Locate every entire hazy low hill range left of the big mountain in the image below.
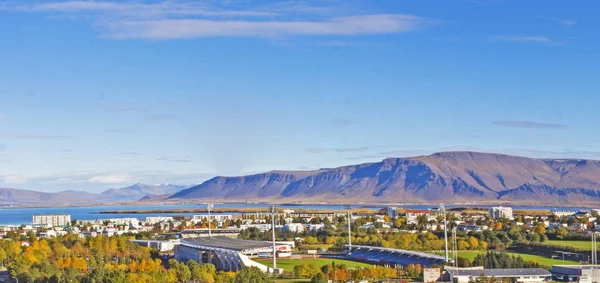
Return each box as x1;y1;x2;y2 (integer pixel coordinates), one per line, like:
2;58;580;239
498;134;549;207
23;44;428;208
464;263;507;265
0;183;186;205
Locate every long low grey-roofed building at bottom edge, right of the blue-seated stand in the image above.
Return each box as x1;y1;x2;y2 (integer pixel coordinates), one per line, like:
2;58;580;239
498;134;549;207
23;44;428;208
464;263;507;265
444;266;552;283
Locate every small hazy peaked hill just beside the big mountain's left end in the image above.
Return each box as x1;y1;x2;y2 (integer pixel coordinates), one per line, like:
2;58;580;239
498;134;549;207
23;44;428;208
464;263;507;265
101;183;187;202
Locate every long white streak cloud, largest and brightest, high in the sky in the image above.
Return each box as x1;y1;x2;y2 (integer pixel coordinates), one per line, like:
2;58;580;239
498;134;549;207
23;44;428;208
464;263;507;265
108;14;426;39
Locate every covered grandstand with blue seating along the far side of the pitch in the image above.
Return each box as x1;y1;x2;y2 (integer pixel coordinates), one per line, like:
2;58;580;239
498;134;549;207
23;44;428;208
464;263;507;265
345;245;445;266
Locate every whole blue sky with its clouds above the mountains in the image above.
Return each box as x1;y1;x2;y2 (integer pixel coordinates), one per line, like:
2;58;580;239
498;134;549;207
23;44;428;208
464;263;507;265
0;0;600;191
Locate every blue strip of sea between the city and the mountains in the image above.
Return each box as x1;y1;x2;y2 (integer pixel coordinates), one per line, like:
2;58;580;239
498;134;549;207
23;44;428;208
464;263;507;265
0;203;589;225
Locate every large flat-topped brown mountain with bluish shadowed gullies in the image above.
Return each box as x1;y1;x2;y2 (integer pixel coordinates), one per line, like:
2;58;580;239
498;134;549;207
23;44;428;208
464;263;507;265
169;152;600;205
